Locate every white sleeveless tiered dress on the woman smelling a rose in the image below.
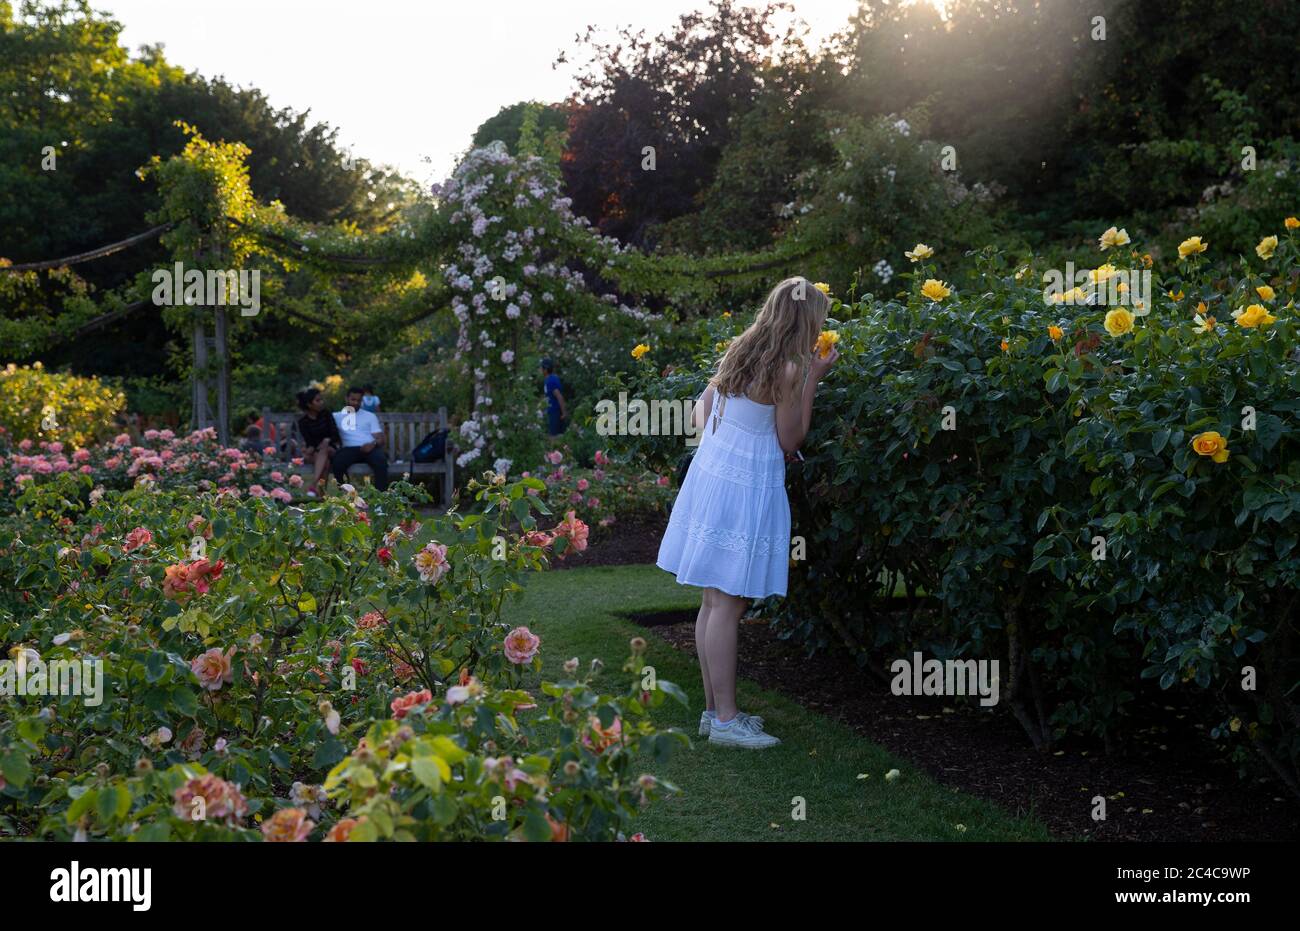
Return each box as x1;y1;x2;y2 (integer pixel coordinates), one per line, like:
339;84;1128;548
658;391;790;598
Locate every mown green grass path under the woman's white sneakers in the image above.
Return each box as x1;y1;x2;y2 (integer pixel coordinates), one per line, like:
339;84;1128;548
507;566;1050;841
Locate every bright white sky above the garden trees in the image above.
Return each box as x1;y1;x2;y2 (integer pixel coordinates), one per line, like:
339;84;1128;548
94;0;878;182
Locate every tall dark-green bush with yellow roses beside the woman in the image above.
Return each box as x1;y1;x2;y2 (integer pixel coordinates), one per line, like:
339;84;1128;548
613;221;1300;789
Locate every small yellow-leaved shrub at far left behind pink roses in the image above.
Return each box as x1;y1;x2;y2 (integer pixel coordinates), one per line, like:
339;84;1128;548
0;361;125;446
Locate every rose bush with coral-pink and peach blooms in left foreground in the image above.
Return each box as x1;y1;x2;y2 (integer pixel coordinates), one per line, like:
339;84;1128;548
0;472;677;840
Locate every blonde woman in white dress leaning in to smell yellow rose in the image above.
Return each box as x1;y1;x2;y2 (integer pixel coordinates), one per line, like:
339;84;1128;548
658;278;839;749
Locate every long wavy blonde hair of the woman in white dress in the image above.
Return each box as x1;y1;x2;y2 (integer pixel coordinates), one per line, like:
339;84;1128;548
709;277;831;404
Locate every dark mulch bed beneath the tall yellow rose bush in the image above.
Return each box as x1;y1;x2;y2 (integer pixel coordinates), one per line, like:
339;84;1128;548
632;611;1300;841
